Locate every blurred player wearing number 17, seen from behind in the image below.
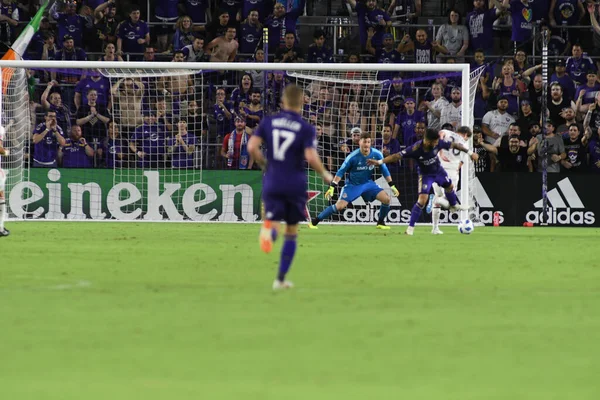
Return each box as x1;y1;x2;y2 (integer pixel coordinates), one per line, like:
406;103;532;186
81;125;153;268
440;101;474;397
248;85;333;290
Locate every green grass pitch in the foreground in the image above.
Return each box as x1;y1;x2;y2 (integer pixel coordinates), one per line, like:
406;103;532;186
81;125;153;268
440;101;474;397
0;222;600;400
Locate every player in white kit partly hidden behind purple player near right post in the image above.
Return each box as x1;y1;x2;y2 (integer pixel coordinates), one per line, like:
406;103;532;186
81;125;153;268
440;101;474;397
428;126;472;235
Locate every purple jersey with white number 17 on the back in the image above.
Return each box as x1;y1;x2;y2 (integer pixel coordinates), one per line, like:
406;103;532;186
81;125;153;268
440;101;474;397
255;111;317;198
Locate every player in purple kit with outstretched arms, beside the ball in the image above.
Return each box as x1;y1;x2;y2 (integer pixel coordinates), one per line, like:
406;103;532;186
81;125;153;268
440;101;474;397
367;128;479;235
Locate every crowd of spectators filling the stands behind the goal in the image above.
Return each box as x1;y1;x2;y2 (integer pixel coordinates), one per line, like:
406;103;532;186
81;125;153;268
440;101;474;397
0;0;600;173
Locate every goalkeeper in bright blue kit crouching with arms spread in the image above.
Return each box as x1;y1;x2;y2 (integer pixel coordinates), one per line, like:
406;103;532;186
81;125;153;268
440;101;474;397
308;132;400;229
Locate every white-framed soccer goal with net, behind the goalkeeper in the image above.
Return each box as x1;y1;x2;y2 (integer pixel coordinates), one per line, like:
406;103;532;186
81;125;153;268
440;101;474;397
0;61;481;223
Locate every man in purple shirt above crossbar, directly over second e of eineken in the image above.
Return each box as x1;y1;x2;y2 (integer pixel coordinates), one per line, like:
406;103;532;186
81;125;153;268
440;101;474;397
117;5;150;61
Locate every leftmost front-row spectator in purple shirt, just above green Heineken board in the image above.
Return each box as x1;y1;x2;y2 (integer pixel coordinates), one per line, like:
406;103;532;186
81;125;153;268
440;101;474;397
31;110;65;168
